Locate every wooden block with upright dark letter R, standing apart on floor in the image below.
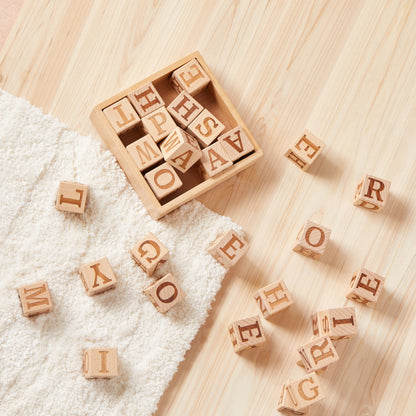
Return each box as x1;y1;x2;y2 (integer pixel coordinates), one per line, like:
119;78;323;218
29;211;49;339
354;175;391;211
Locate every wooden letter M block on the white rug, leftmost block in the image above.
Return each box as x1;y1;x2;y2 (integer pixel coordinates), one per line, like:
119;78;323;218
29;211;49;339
17;280;53;316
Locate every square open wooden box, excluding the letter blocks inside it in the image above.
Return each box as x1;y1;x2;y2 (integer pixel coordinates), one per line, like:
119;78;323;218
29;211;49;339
90;52;263;219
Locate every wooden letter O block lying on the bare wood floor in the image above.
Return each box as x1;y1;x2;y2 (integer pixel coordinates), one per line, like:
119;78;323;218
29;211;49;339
293;220;331;260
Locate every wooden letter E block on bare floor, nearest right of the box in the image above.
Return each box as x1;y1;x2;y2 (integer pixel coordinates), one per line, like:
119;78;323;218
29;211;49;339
285;130;325;170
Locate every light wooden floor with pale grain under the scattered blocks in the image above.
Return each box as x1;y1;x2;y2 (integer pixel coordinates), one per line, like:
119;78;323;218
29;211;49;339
0;0;416;416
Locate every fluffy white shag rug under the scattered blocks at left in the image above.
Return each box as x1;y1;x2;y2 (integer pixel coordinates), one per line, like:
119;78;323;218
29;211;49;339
0;90;241;416
